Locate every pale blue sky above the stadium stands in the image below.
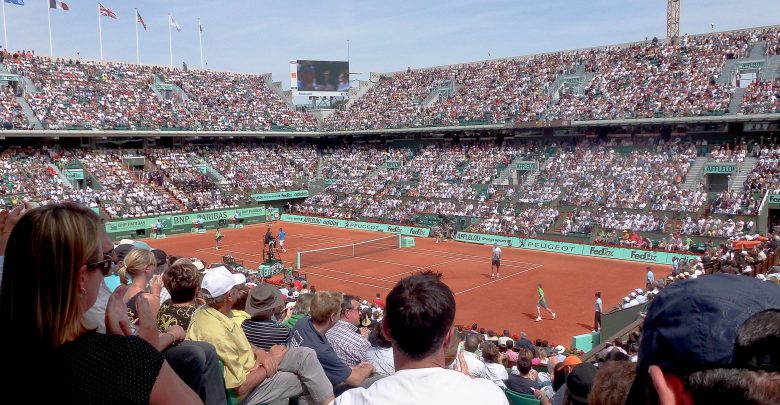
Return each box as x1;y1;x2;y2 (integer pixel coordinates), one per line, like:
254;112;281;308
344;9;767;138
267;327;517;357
5;0;780;88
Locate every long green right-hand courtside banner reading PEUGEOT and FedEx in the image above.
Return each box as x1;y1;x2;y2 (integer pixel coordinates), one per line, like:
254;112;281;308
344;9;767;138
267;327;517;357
455;232;699;264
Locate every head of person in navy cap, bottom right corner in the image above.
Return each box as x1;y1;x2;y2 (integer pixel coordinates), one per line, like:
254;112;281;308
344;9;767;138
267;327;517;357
626;274;780;405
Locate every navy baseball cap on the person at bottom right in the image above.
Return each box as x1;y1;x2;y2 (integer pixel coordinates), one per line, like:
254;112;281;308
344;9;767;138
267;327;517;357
637;274;780;375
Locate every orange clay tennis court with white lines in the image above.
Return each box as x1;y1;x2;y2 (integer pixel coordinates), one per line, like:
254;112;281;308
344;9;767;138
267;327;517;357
146;221;652;347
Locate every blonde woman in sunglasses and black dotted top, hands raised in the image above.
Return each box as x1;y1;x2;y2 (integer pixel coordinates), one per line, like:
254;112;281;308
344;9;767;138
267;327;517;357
0;203;200;404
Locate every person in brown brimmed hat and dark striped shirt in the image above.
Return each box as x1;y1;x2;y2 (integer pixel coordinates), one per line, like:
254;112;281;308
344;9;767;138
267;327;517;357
241;282;290;350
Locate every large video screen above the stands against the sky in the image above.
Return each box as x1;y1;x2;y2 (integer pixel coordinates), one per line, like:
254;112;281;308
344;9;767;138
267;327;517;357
290;60;349;95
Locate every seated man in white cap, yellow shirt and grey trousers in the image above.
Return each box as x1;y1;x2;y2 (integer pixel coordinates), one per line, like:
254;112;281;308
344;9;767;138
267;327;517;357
187;266;333;404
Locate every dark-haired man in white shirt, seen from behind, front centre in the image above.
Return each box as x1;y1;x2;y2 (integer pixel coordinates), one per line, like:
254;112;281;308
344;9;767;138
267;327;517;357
335;272;509;405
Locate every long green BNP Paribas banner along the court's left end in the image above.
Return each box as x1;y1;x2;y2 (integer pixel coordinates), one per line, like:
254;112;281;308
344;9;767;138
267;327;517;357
106;207;266;233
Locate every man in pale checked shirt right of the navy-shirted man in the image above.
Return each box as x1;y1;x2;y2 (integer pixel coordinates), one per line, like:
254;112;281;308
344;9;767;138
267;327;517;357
325;294;371;366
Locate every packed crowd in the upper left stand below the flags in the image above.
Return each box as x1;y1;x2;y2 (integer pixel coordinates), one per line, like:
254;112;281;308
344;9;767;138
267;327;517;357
3;52;317;131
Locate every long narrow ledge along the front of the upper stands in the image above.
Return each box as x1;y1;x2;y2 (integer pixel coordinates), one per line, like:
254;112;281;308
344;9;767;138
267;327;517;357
0;113;780;139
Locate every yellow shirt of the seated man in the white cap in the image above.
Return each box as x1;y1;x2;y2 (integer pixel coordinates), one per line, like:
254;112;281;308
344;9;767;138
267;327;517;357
187;305;255;388
